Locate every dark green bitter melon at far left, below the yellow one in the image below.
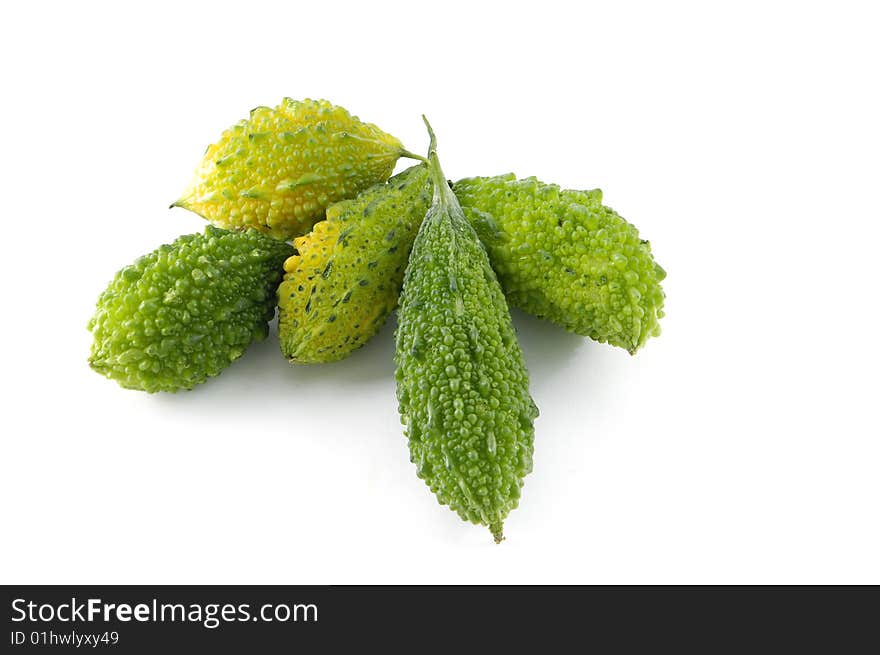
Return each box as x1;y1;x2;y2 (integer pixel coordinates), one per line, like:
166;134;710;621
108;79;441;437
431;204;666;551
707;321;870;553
89;227;293;393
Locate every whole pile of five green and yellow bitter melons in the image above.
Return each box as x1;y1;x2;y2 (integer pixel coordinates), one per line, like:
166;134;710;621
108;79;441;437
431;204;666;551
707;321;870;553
89;99;665;541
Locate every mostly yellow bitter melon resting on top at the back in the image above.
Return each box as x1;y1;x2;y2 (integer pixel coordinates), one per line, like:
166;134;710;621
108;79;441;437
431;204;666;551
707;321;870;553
172;98;403;239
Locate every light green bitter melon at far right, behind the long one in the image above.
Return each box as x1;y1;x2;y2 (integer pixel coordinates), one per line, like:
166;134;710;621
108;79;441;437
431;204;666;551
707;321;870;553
454;174;666;353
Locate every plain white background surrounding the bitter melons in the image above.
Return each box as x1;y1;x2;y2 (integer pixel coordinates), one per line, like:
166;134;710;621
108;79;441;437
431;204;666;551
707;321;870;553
0;0;880;583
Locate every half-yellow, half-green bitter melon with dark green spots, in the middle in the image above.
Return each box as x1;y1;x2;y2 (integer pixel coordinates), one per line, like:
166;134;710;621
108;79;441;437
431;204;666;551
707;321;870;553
278;164;431;363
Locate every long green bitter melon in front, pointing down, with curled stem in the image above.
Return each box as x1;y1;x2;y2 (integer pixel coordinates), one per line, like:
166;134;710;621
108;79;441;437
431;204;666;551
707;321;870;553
396;154;538;542
